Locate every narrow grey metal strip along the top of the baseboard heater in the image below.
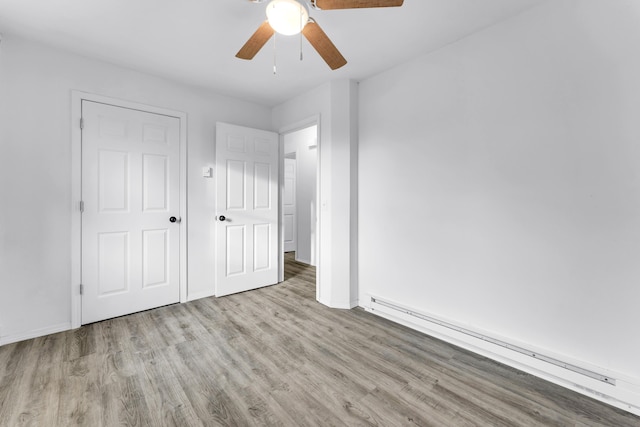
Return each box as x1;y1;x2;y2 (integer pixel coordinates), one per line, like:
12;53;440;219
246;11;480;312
371;297;616;386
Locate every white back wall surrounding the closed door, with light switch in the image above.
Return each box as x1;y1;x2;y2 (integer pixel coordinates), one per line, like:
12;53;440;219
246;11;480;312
0;35;271;343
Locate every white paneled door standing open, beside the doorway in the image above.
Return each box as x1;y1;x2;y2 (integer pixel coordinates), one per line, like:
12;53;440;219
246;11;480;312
215;123;279;296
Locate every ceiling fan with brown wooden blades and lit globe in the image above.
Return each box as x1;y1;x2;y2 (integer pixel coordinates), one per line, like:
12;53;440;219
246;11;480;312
236;0;404;70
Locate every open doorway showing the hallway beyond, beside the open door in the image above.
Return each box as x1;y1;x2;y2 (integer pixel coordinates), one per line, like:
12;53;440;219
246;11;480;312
281;124;318;266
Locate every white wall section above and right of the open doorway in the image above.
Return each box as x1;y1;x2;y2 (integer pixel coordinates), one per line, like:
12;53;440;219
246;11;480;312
273;80;358;308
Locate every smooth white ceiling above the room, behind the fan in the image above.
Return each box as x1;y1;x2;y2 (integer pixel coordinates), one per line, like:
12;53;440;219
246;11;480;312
0;0;544;106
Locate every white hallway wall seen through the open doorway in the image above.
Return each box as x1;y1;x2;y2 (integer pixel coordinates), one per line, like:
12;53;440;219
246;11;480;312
283;125;318;265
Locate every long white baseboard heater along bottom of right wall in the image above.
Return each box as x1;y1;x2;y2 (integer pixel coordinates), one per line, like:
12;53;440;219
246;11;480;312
363;296;640;415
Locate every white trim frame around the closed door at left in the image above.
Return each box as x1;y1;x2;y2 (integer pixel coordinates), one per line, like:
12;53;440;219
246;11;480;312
71;90;188;329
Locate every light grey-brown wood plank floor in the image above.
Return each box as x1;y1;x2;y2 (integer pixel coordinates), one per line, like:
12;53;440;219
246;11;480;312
0;252;640;427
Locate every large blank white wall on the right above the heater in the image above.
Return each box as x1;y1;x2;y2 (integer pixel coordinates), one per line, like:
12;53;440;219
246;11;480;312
359;0;640;411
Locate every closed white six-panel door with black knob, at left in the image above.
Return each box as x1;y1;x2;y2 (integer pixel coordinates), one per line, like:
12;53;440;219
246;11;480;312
82;100;180;324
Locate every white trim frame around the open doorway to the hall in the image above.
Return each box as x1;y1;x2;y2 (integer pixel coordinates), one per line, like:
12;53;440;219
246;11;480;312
278;114;322;300
